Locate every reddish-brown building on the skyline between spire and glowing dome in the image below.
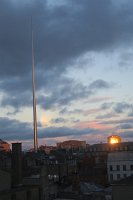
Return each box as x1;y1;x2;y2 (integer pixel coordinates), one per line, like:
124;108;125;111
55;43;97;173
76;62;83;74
57;140;86;149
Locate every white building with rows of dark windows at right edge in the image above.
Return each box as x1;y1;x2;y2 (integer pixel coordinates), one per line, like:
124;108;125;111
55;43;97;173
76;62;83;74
107;151;133;182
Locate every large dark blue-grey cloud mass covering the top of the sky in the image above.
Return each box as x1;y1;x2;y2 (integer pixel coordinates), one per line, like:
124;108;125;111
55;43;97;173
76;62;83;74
0;0;133;111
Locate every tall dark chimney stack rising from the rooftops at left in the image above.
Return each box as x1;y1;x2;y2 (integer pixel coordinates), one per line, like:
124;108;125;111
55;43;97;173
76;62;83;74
12;143;22;187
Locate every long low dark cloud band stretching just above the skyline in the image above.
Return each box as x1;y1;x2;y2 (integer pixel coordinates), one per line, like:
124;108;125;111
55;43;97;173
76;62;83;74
0;117;133;144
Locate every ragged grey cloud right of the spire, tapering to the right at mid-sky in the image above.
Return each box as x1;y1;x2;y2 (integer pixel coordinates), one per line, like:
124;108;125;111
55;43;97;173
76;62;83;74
39;79;111;109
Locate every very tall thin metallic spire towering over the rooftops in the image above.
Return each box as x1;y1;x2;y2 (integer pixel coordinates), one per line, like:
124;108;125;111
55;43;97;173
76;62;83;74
31;17;38;152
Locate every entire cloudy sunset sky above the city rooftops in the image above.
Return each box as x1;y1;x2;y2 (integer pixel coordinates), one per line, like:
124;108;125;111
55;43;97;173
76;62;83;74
0;0;133;148
